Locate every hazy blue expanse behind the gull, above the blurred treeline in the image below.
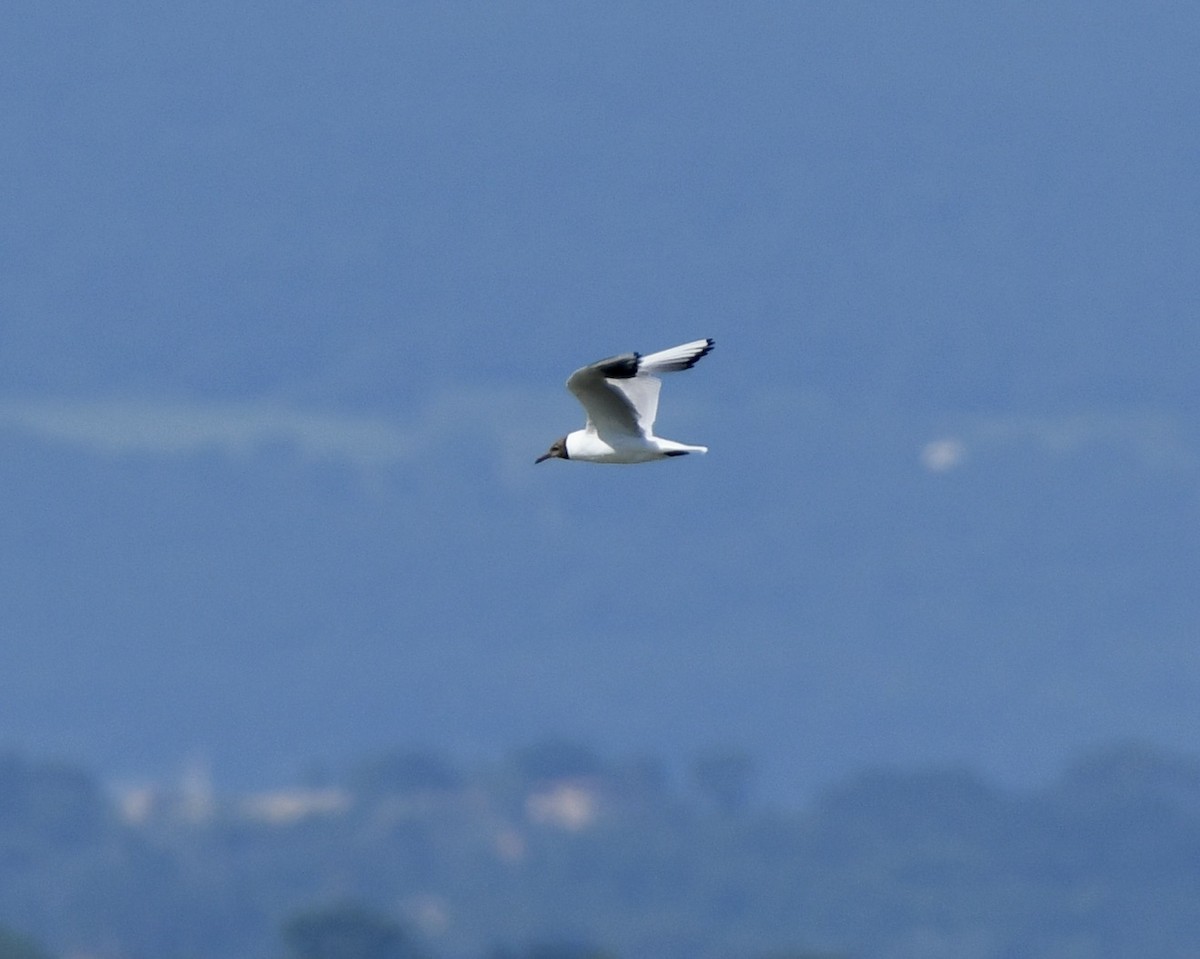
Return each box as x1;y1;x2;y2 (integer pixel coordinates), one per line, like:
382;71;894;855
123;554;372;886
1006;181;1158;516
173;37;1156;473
0;2;1200;792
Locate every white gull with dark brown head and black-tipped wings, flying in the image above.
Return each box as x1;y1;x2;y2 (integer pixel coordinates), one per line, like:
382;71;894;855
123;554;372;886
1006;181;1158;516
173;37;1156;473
535;340;713;463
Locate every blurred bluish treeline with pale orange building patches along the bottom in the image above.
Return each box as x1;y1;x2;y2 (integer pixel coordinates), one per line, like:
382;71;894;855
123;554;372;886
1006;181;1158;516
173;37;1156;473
0;742;1200;959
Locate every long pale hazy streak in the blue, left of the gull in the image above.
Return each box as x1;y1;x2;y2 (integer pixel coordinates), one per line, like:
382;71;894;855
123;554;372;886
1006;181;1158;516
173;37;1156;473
0;400;419;467
